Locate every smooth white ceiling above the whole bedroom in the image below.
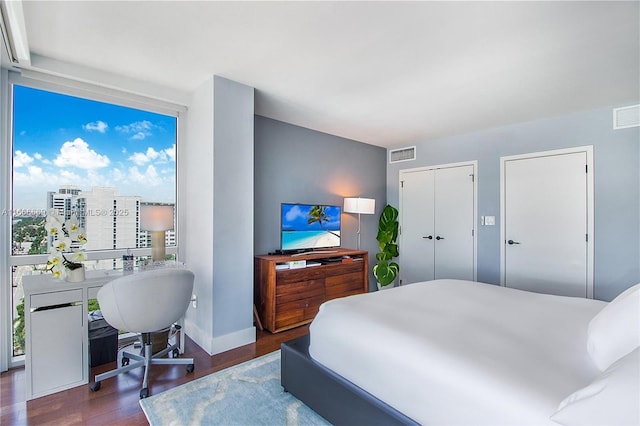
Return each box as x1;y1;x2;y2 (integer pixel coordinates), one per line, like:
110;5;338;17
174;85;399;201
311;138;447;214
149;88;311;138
12;1;640;147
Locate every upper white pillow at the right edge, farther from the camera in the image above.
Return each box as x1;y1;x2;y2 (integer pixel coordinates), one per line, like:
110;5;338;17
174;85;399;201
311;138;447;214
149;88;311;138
587;284;640;371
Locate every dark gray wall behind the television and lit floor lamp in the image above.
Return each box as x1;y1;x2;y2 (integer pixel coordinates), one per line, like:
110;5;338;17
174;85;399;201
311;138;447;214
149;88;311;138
254;116;387;288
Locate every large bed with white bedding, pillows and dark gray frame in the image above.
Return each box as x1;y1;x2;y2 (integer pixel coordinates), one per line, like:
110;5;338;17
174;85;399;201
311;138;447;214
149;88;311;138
282;280;640;425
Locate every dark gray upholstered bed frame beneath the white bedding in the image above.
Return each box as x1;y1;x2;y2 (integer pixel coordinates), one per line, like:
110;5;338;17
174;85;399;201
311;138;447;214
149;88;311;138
280;335;418;425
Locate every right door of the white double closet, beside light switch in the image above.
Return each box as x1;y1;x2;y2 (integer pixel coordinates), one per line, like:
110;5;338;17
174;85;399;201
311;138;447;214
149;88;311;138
433;165;475;281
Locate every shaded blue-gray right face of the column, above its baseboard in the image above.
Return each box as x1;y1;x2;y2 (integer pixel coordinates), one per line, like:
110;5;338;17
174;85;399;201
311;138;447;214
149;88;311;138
214;76;254;336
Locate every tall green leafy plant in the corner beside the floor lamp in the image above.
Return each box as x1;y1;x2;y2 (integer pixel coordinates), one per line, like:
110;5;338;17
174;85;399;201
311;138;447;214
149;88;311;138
373;204;400;289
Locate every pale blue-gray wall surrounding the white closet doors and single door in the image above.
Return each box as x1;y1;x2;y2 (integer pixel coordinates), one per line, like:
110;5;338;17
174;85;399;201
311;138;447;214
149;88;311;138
387;107;640;300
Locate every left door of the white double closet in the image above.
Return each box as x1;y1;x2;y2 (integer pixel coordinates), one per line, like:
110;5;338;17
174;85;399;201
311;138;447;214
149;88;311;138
399;170;435;284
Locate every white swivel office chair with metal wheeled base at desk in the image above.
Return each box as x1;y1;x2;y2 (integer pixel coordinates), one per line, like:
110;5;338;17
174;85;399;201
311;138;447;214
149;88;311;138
91;268;194;398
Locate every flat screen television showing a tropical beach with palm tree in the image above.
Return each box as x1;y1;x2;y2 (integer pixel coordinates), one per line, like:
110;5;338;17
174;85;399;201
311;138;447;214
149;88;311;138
280;203;341;252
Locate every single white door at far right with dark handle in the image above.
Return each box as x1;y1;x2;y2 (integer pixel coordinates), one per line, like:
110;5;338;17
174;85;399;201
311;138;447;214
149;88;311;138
502;150;592;297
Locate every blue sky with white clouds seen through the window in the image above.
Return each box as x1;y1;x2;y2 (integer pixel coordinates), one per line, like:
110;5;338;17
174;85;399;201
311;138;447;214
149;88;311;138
13;86;176;209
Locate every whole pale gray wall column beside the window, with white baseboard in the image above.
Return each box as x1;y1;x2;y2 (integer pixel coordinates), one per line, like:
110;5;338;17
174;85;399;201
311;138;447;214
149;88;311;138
178;76;256;354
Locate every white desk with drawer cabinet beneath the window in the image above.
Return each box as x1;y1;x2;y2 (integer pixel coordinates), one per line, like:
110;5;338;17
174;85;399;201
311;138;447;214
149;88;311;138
22;271;184;400
